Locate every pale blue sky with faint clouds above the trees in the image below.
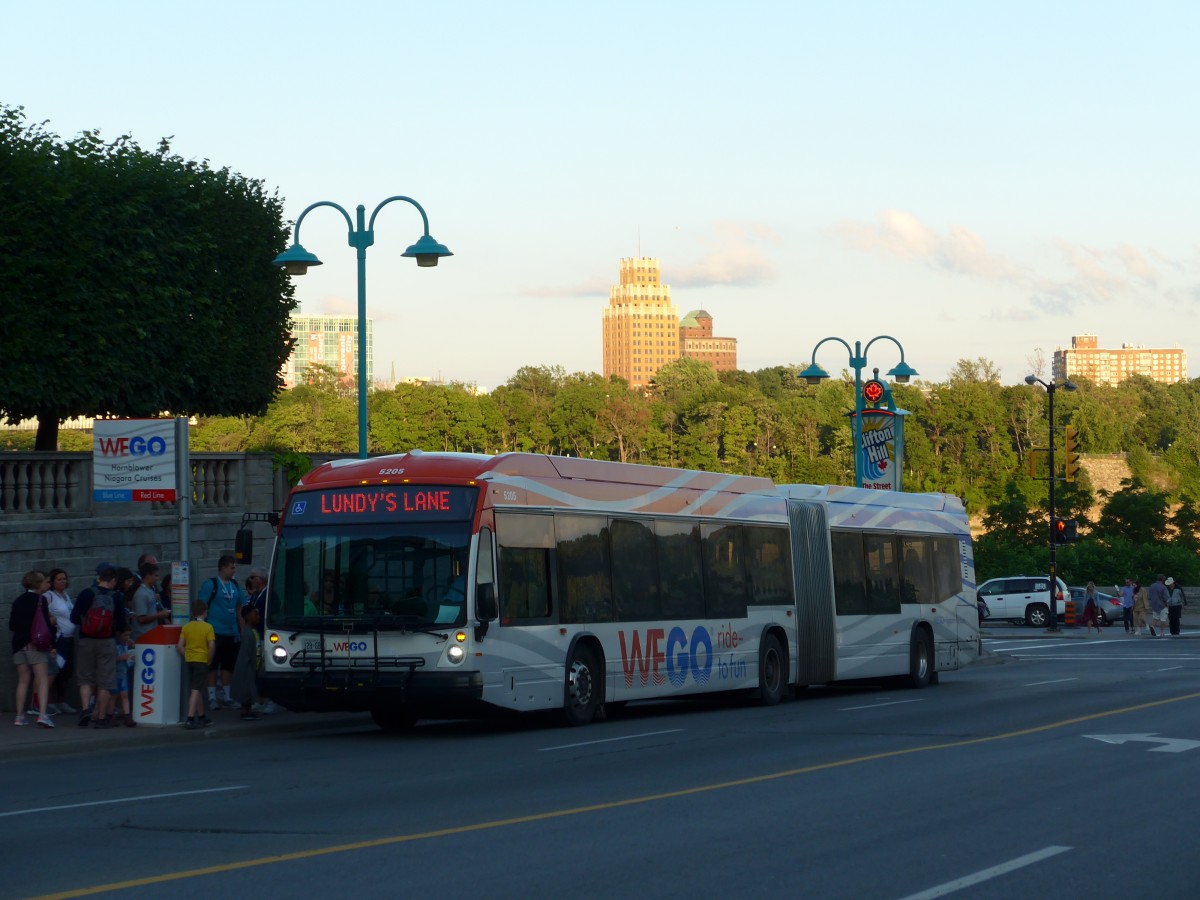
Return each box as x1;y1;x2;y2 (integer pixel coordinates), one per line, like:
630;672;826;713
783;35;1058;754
0;0;1200;389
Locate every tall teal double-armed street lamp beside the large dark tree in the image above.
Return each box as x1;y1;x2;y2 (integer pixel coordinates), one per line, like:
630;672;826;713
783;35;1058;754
275;197;454;460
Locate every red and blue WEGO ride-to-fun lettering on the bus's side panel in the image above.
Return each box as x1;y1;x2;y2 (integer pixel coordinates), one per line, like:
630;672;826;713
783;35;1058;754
618;625;745;688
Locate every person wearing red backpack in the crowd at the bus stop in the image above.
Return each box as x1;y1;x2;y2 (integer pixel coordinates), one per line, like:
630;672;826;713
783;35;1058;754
71;563;126;728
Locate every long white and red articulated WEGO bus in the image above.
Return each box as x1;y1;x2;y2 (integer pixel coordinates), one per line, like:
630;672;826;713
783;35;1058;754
260;450;979;730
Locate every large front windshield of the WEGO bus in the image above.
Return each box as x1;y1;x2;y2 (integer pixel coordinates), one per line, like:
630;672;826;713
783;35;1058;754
266;522;470;630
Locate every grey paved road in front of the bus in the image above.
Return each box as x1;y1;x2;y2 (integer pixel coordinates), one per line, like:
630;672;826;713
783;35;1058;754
0;630;1200;898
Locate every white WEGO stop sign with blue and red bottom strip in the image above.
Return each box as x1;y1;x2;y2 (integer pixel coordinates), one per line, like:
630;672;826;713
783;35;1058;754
91;419;175;503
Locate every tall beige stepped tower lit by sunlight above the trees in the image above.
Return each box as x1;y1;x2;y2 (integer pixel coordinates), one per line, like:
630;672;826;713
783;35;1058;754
604;257;679;388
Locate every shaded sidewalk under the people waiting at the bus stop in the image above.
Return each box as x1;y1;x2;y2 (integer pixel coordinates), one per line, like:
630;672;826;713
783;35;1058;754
0;707;371;762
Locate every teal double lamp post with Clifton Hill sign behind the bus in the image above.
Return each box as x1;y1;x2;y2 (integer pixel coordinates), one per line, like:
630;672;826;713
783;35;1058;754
798;335;919;491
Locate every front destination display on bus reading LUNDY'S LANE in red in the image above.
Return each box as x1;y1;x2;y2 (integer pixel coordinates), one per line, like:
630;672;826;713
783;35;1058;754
286;485;479;526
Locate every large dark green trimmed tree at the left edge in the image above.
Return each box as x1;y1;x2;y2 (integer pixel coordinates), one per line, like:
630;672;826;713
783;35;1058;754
0;106;294;450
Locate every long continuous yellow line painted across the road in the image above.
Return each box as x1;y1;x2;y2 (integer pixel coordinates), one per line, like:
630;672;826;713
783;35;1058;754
38;692;1200;900
